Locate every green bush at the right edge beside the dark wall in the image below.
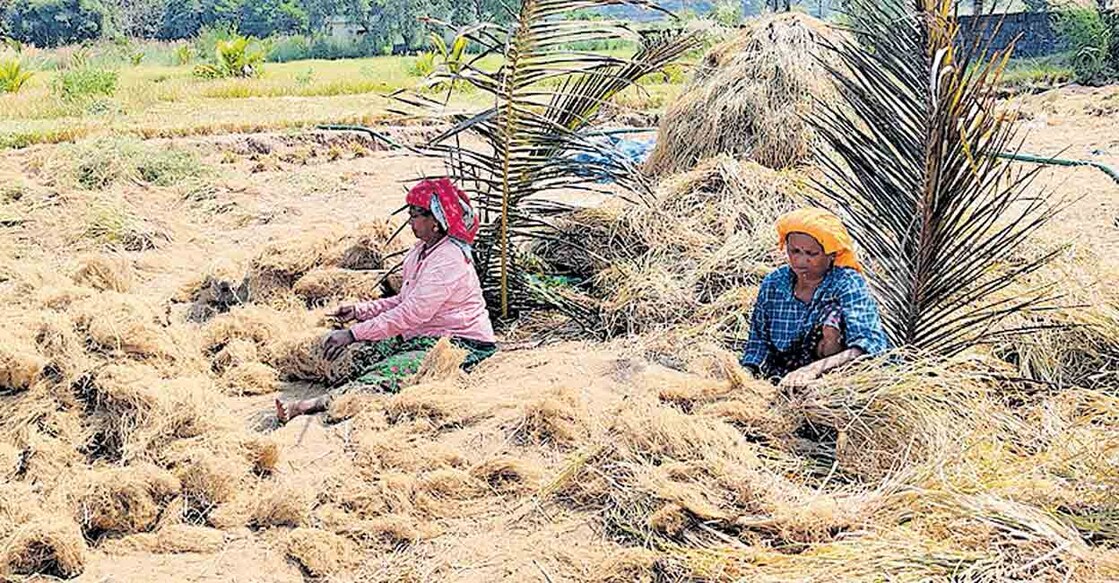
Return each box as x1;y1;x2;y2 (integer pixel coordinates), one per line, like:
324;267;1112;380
1054;7;1119;85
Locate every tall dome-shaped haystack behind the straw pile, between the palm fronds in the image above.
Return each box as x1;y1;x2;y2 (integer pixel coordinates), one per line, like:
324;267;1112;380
645;12;830;176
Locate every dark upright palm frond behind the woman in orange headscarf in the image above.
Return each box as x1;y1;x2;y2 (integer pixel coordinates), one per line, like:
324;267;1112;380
814;0;1061;352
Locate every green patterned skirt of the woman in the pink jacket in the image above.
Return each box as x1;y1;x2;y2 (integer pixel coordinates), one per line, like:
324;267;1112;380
326;337;497;393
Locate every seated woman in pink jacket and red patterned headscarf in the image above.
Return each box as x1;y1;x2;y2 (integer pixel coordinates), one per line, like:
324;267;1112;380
275;178;497;423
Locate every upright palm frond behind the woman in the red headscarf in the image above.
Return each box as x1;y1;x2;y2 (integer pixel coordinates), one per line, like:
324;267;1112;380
397;0;699;318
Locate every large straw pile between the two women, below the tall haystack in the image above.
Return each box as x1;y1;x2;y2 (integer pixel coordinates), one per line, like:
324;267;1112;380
536;156;805;344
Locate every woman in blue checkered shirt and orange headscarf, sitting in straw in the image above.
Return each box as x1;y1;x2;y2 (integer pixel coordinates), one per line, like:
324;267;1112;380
742;208;890;386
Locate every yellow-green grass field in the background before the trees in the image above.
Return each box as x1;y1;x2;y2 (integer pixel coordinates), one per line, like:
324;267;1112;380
0;46;683;148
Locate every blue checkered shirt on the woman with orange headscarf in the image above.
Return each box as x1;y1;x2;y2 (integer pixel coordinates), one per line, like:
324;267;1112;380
742;265;890;370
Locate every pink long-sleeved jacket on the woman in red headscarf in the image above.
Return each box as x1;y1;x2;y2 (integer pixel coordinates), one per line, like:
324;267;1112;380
350;237;495;342
